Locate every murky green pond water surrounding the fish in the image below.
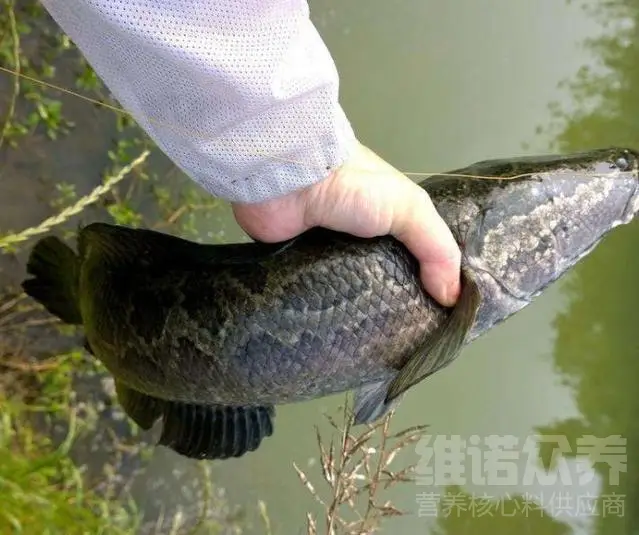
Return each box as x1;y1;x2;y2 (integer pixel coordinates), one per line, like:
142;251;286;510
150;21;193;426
0;0;639;535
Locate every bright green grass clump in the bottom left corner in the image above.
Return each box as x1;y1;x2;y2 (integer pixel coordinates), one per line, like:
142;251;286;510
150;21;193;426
0;399;139;534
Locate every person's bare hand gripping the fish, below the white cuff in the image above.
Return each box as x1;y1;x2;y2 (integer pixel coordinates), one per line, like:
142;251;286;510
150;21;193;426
233;144;461;306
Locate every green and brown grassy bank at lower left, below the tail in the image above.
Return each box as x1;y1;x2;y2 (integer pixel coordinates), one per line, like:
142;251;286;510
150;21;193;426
0;294;140;534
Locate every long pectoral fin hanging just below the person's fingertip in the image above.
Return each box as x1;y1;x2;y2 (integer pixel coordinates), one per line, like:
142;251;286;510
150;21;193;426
385;273;481;403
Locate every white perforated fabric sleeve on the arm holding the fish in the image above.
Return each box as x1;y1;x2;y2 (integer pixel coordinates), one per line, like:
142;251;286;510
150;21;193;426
42;0;355;202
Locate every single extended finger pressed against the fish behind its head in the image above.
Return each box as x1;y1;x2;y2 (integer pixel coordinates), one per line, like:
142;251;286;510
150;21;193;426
391;179;461;306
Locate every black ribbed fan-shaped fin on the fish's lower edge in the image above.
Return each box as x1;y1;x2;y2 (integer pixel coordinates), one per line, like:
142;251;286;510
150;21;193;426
159;402;275;460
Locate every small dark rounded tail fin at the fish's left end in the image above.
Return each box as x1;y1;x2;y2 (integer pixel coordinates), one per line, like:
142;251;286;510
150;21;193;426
22;236;82;325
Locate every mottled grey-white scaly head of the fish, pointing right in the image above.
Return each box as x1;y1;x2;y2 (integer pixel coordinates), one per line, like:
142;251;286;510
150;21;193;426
440;149;639;340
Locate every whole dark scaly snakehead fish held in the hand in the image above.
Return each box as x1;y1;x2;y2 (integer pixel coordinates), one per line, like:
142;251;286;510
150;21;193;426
22;147;639;460
